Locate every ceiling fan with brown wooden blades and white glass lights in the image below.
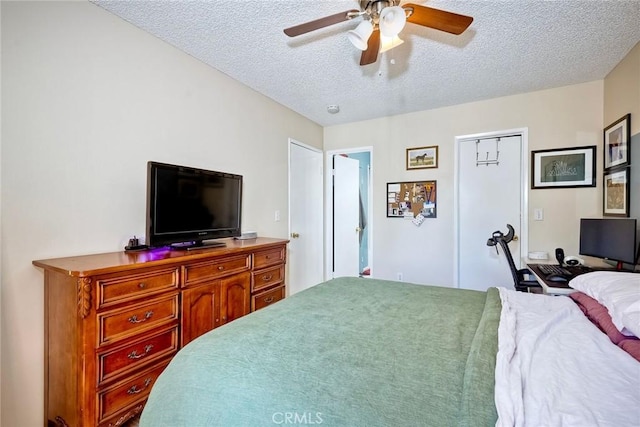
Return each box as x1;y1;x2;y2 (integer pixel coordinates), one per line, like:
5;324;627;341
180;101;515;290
284;0;473;65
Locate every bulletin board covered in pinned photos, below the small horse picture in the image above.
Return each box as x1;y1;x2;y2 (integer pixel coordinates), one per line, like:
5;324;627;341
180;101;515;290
387;181;437;219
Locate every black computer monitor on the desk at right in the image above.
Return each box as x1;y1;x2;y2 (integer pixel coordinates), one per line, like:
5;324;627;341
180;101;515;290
580;218;638;270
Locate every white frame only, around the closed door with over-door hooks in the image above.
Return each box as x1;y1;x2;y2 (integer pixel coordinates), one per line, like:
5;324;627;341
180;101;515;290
453;127;529;288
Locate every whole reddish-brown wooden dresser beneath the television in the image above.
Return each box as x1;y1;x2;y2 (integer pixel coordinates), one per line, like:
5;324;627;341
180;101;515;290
33;237;287;427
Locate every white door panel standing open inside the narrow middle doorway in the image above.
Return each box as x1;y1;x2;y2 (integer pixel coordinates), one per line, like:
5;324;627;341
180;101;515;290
332;155;360;277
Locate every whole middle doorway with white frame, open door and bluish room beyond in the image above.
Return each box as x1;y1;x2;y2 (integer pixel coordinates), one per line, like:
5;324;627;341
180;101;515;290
325;147;373;279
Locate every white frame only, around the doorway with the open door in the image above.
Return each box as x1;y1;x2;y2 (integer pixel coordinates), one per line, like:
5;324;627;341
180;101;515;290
324;146;375;280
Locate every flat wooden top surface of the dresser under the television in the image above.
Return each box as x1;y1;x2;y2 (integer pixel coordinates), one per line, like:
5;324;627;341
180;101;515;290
33;237;288;277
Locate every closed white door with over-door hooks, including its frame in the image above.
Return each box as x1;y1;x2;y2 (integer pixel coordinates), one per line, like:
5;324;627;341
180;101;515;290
454;128;528;291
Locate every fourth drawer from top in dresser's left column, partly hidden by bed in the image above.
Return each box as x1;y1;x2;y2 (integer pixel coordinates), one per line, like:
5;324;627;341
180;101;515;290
97;361;169;425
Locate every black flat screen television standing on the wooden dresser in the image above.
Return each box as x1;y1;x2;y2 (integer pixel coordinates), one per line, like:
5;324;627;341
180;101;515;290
146;162;242;249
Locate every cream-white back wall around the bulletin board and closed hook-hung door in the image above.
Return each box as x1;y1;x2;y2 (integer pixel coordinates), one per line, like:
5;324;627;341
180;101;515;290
324;81;603;286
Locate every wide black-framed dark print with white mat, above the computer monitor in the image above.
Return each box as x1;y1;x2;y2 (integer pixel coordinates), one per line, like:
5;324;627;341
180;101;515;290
531;145;596;189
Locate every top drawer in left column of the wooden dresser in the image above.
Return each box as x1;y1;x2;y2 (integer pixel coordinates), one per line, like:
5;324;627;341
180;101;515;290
96;267;179;309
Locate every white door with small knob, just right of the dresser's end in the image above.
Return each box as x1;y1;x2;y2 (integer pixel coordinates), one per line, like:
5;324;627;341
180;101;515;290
287;138;324;295
